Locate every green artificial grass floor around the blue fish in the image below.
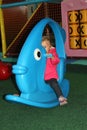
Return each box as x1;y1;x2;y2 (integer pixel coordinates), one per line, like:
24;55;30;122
0;64;87;130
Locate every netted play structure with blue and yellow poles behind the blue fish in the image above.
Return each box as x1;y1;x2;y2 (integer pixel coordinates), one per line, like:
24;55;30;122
0;0;61;62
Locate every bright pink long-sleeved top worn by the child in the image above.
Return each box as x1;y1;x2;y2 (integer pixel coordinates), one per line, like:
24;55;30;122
44;47;60;80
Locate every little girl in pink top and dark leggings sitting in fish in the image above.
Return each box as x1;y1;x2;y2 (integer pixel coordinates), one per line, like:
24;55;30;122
42;36;67;106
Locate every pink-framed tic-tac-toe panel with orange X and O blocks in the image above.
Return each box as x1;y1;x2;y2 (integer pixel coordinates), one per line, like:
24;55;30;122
61;0;87;58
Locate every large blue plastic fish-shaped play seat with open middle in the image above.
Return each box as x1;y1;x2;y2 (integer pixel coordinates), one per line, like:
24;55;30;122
5;18;69;108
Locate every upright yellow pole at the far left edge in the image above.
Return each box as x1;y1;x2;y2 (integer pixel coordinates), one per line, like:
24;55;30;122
0;0;6;58
